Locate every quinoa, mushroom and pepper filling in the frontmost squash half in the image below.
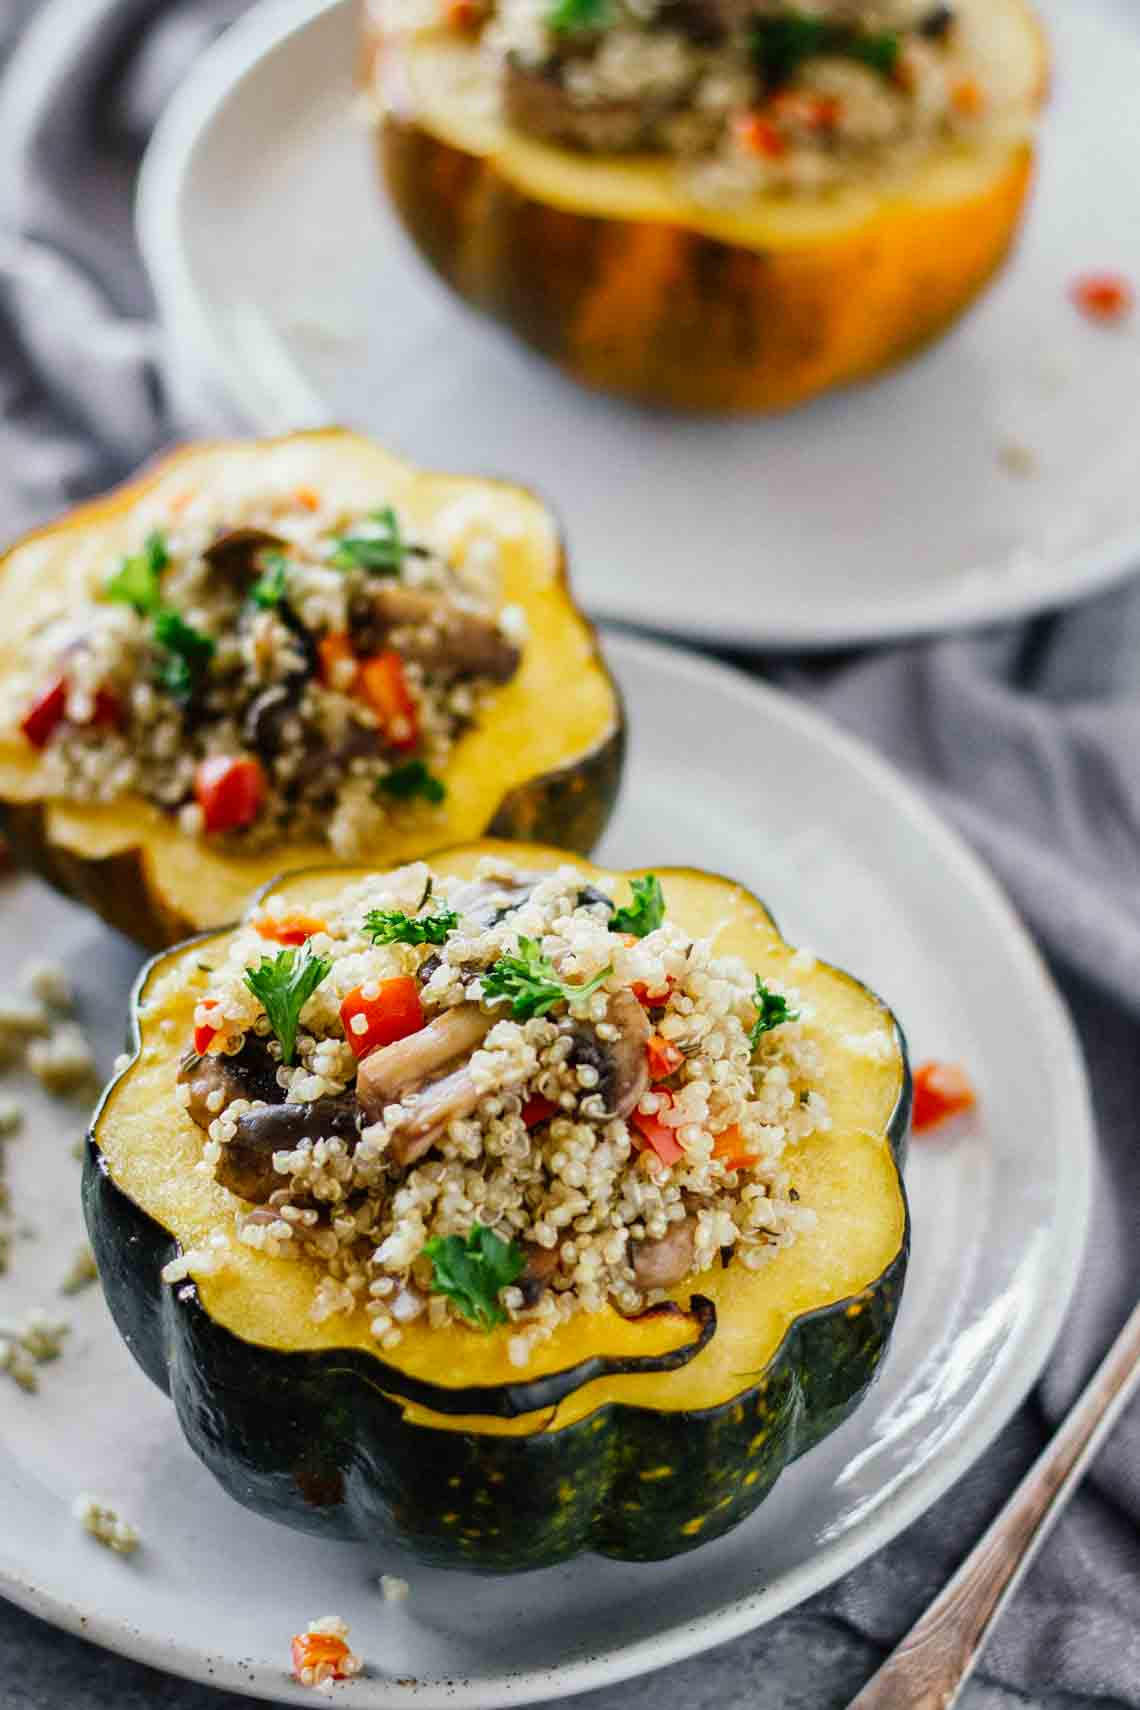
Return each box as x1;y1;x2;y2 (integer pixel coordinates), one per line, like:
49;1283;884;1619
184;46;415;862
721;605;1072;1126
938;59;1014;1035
171;857;831;1366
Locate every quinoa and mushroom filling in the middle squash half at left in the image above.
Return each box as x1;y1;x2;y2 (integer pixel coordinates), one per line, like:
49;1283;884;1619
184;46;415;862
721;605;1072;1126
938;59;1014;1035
3;487;525;858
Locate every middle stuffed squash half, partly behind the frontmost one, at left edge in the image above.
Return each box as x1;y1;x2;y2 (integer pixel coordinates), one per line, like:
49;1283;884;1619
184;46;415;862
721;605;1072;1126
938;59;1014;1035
0;431;624;949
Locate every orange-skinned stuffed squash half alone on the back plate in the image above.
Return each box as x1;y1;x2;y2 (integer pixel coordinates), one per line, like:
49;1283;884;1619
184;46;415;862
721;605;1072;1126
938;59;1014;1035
364;0;1046;410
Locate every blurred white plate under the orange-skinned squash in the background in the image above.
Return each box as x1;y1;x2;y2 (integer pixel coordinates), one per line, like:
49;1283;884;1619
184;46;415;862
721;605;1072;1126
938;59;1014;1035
140;0;1140;646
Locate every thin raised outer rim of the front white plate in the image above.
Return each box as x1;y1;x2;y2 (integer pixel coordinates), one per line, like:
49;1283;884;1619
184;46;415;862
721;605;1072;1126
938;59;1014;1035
0;634;1094;1710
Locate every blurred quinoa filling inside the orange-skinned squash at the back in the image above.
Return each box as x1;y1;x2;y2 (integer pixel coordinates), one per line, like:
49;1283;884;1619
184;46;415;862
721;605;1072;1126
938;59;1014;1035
440;0;1031;195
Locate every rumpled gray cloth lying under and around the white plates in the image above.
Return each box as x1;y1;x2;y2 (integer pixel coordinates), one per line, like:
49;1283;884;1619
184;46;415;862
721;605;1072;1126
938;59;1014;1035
0;0;1140;1710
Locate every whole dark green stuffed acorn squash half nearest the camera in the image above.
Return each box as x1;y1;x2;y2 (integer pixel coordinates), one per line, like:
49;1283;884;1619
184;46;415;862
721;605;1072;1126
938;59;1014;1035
84;843;909;1571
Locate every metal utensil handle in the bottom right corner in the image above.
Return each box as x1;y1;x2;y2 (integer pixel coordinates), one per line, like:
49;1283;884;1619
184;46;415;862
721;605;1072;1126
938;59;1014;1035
849;1305;1140;1710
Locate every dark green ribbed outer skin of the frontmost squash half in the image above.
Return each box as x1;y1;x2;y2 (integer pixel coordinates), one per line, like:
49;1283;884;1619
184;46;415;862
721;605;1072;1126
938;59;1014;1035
82;934;911;1573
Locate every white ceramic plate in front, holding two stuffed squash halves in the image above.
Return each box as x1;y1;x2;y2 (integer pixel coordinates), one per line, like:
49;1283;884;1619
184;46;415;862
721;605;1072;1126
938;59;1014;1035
0;640;1090;1710
